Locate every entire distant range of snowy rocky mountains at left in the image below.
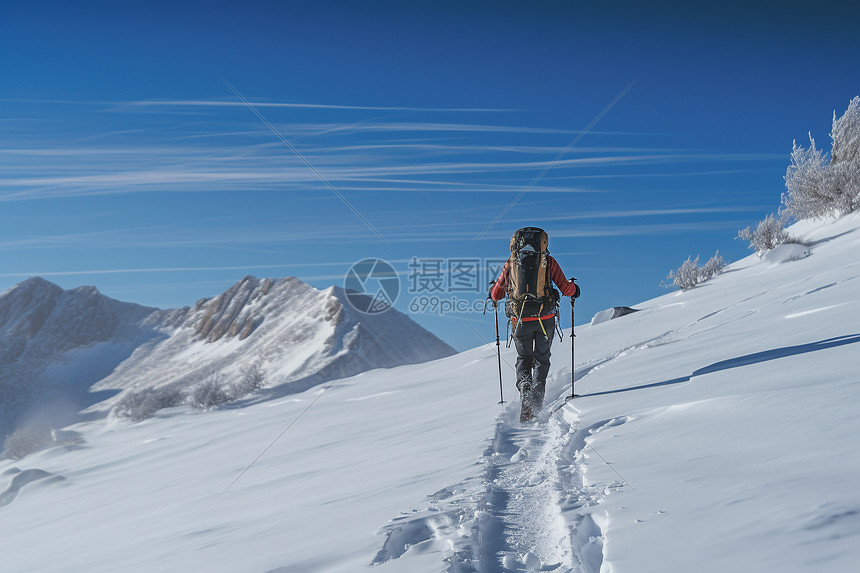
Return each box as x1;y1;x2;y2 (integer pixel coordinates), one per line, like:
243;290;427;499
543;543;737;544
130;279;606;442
0;276;455;437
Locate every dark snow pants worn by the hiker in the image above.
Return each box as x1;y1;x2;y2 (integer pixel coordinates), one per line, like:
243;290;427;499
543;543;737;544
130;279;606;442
514;316;555;410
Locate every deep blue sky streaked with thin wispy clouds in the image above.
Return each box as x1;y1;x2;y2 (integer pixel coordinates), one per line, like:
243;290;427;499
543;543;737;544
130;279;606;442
0;2;860;349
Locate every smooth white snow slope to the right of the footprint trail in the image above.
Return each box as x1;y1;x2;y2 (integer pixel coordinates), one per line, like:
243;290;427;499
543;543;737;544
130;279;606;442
565;214;860;572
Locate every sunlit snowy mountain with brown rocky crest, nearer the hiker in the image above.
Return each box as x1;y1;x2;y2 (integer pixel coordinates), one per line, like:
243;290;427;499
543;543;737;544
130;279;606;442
89;277;454;409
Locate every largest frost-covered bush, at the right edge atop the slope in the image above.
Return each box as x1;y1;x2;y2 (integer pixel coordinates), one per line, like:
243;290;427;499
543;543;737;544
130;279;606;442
782;97;860;219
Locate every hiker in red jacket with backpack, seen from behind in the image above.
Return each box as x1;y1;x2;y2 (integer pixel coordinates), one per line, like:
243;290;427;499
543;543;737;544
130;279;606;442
489;227;580;421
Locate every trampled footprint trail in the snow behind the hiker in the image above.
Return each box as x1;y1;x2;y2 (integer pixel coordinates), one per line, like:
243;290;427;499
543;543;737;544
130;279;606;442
371;378;624;573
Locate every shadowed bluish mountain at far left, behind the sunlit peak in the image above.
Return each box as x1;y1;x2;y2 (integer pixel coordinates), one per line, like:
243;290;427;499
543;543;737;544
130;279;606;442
0;278;156;435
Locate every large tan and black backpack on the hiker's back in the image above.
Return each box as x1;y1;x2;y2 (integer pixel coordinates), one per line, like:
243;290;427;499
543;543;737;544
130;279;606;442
505;227;560;319
